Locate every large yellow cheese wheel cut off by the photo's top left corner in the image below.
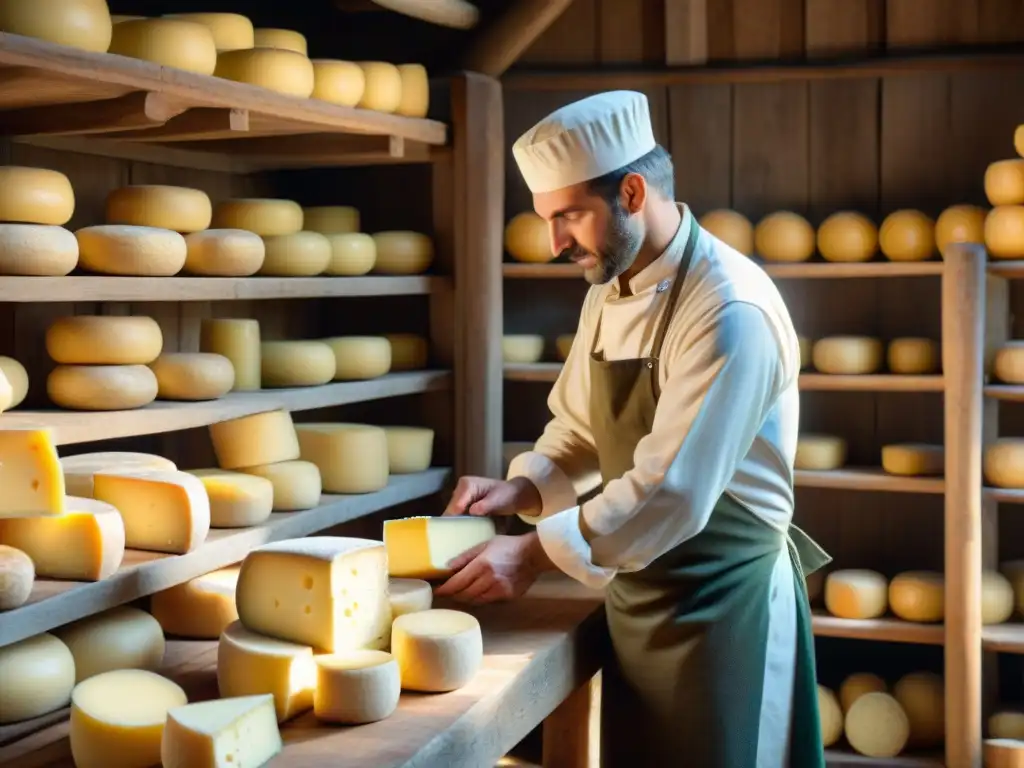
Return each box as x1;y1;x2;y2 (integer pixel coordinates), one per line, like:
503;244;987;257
0;0;113;51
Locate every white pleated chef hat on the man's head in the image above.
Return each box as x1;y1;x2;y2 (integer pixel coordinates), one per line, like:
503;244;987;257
512;91;657;194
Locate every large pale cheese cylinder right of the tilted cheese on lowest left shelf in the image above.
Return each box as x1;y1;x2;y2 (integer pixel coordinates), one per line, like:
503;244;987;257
295;423;388;494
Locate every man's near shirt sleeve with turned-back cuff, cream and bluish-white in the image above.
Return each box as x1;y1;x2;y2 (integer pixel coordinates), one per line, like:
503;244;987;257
538;301;784;588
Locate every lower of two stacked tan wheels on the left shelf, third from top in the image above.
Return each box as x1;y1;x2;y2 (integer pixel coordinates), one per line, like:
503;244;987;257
46;366;158;411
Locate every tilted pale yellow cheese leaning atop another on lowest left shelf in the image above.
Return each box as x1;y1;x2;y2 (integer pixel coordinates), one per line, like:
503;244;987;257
210;411;299;469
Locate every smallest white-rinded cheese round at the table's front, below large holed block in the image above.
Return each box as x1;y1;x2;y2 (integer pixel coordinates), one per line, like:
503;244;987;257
313;650;401;725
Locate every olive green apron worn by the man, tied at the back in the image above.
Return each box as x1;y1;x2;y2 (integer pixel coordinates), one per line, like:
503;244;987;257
590;218;830;768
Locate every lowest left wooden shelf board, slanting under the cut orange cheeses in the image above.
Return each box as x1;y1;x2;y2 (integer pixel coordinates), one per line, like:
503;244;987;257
0;469;449;647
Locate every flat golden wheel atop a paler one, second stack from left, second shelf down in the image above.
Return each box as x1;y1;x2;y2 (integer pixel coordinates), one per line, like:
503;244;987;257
106;184;213;232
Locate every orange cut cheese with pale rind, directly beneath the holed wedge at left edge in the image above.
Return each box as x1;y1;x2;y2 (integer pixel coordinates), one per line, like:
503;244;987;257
0;495;125;581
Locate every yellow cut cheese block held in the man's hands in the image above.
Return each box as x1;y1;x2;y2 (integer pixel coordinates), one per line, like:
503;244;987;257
384;515;495;579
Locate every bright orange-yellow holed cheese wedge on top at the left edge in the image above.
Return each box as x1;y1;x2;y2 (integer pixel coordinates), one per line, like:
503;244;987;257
0;429;66;518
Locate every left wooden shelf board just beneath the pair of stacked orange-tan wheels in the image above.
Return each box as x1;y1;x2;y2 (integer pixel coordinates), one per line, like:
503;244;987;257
0;371;452;445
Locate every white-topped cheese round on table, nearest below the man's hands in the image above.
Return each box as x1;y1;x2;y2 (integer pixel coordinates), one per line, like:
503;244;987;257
391;608;483;693
